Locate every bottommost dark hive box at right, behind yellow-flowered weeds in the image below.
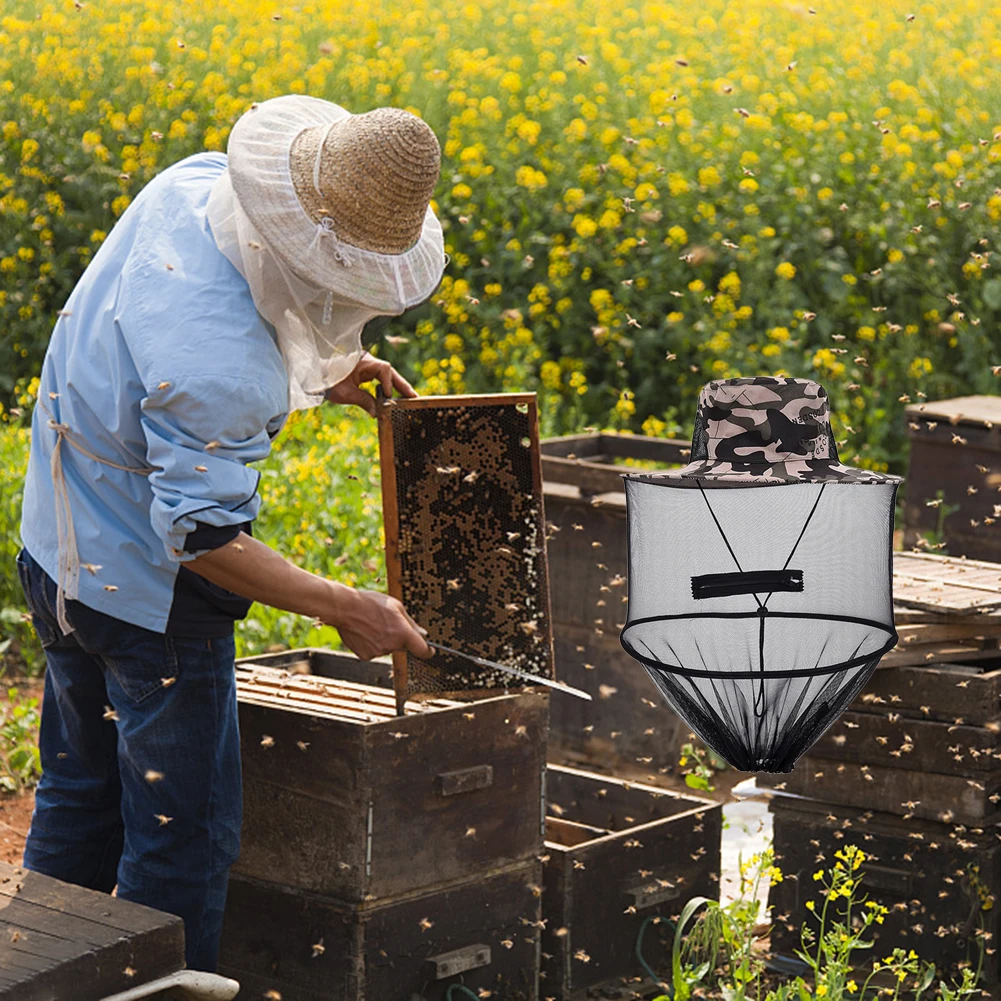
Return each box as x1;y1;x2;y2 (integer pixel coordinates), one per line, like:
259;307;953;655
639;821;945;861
769;796;1001;987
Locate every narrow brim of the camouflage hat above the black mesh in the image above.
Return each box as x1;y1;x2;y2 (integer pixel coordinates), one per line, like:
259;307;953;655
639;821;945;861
625;458;904;487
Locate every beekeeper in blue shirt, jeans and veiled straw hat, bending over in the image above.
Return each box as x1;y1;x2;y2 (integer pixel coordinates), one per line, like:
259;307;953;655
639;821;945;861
17;95;445;970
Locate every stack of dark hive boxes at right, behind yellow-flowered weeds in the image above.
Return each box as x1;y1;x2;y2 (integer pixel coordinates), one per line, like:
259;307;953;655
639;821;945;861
758;658;1001;986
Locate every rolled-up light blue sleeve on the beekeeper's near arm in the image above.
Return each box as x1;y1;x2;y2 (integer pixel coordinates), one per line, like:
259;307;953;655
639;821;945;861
141;373;280;563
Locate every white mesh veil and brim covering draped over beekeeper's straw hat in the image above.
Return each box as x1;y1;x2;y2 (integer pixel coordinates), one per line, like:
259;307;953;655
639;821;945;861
206;95;445;410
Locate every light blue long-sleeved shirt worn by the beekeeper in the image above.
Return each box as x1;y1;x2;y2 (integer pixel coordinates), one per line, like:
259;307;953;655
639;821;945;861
21;152;288;633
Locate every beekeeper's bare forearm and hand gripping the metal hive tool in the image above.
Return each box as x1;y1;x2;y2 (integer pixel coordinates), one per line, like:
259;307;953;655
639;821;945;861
185;533;432;660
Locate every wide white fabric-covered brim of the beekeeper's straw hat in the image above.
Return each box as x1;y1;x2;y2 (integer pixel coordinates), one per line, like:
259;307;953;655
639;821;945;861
226;94;445;313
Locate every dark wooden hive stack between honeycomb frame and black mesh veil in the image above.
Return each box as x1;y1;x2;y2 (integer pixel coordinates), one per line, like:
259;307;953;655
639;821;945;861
541;432;690;772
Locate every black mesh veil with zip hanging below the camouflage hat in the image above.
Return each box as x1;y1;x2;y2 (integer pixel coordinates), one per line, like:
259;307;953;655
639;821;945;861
620;475;898;772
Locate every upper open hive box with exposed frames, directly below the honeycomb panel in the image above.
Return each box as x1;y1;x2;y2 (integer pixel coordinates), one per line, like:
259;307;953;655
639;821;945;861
233;650;549;902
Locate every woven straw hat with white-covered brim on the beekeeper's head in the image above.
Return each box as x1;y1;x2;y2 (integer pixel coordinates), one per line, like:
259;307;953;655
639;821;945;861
226;94;444;313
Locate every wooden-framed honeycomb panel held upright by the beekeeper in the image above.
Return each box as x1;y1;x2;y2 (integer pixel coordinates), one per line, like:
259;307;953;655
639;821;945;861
376;390;555;706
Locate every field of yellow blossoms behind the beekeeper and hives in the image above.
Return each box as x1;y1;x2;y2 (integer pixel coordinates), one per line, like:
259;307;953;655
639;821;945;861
0;0;1001;652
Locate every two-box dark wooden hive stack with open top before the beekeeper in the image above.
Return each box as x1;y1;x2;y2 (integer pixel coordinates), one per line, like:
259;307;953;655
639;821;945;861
220;651;549;1001
